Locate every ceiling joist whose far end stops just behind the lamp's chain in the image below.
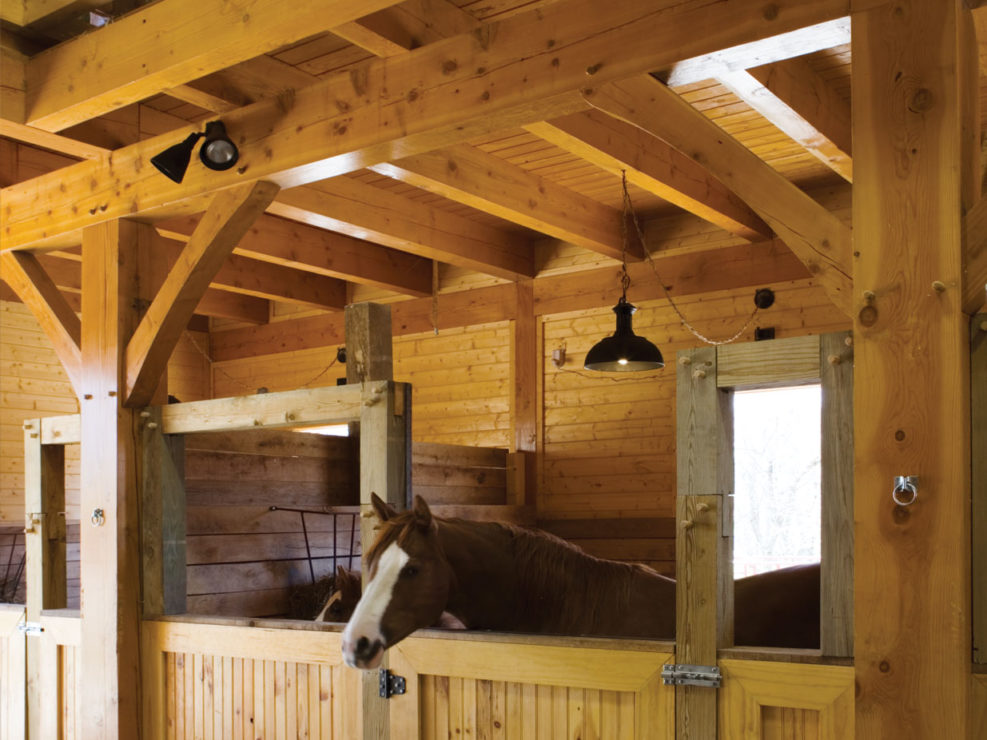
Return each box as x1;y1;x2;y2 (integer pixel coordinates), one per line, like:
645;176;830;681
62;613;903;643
371;144;628;259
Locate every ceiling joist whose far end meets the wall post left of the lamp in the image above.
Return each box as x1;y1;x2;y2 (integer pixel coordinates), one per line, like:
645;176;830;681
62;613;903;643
268;177;535;280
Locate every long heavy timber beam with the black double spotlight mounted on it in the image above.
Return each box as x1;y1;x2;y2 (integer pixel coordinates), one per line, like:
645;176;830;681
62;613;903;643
0;0;846;249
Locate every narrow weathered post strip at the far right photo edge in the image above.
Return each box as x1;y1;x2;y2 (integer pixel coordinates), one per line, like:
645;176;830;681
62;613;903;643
970;313;987;665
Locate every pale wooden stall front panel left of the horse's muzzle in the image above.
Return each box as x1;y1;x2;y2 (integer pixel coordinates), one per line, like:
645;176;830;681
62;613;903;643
141;619;363;740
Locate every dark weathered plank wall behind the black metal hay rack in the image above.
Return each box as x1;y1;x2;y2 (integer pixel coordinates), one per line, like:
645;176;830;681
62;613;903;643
185;431;360;616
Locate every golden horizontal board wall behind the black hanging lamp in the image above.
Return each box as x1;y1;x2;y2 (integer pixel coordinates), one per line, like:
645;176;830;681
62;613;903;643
538;280;848;532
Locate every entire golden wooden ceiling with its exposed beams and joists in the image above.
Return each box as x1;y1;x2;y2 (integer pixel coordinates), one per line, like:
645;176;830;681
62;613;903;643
0;0;983;346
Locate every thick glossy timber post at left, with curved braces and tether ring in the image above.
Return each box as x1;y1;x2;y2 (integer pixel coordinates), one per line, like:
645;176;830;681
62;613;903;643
78;221;149;740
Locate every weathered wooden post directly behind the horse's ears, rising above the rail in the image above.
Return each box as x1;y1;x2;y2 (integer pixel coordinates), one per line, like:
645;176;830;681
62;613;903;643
345;303;411;740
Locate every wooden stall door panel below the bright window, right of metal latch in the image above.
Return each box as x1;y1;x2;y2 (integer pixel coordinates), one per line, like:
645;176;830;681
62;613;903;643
718;660;854;740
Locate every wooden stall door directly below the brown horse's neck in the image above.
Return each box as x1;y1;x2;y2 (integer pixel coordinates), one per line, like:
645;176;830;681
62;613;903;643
390;634;675;740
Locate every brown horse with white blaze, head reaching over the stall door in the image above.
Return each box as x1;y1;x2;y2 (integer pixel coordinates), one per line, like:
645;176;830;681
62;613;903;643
343;496;819;668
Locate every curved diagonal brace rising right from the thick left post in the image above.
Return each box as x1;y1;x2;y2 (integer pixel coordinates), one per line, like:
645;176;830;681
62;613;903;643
124;182;278;406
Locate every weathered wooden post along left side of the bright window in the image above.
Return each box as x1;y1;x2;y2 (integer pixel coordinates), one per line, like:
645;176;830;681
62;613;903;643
675;347;733;740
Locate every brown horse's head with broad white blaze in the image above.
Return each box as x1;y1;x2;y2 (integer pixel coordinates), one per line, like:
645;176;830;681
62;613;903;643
342;494;452;670
